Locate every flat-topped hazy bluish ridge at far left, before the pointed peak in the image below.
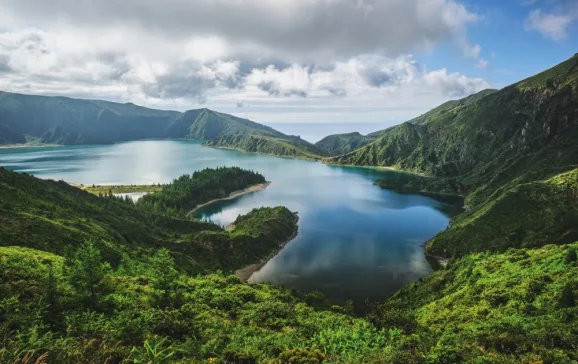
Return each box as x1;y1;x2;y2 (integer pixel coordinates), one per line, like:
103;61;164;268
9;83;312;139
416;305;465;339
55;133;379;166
0;92;179;144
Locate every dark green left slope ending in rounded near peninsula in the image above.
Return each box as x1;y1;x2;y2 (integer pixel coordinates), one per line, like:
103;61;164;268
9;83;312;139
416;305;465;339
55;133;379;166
0;169;295;272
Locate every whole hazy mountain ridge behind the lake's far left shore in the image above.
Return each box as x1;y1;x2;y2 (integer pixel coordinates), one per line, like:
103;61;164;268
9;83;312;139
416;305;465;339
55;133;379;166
0;92;326;158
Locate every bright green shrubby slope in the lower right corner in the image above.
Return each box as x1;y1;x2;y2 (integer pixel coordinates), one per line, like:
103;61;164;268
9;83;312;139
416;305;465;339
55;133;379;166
373;243;578;363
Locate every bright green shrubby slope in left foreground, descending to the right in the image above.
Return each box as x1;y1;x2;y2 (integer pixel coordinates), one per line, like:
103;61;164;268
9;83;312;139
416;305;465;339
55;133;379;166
0;247;395;363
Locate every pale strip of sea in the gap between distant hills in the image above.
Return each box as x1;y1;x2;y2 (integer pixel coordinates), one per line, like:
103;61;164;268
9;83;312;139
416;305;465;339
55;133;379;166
263;123;391;143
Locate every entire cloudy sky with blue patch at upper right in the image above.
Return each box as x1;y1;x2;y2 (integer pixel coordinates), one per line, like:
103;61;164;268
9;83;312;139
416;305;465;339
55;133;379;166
0;0;578;133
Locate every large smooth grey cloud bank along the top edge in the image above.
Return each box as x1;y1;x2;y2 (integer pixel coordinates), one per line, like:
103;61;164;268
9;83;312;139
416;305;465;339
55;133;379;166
0;0;477;62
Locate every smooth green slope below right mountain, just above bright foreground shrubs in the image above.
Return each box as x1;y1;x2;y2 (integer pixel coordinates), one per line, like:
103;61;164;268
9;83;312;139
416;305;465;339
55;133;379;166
428;169;578;256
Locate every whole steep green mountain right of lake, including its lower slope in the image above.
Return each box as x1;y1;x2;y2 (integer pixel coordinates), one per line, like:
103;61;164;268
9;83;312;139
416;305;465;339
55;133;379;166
329;56;578;257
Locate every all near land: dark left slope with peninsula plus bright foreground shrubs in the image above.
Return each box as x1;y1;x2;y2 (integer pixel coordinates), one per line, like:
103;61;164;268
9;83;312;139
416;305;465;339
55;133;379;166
0;166;578;364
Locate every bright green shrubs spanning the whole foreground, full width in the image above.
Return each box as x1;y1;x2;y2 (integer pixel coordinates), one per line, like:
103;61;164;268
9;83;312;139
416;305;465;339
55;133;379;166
0;235;578;364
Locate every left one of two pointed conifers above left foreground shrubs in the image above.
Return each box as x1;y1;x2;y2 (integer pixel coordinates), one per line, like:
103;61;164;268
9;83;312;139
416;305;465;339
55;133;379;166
69;241;109;307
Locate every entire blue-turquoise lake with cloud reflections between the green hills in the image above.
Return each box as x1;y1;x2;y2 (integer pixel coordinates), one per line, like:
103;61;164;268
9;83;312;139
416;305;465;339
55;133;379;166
0;140;459;303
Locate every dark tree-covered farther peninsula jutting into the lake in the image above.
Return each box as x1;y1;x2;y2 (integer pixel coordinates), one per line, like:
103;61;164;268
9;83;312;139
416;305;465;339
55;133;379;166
137;167;266;215
